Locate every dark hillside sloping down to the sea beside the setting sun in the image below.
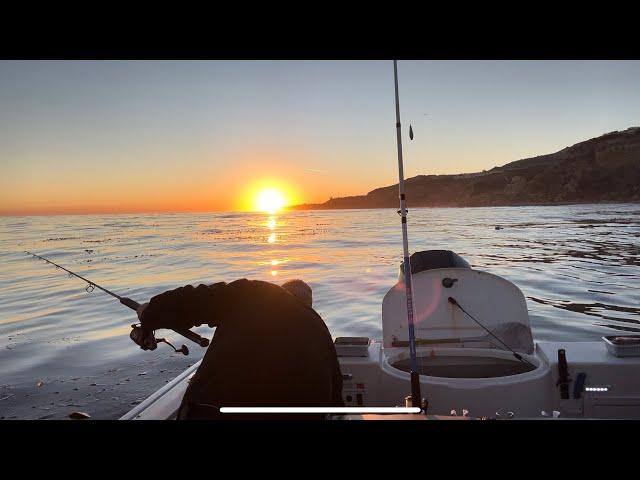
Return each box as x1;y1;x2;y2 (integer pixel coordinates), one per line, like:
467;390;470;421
292;127;640;210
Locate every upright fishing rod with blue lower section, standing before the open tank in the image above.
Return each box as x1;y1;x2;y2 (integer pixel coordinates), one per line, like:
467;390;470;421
393;60;422;408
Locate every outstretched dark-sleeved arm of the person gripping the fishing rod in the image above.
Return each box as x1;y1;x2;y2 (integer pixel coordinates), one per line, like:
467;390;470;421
138;282;228;331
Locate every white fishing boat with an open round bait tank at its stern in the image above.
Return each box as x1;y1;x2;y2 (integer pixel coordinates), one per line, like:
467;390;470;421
122;250;640;420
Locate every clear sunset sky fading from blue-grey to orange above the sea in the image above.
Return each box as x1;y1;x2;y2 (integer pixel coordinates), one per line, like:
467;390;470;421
0;61;640;215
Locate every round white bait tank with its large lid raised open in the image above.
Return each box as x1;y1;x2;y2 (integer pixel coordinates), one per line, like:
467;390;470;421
340;250;552;416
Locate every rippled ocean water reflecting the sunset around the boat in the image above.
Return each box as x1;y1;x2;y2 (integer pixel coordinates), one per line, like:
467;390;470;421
0;204;640;419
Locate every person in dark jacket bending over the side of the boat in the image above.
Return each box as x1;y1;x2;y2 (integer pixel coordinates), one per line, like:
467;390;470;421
130;279;344;419
